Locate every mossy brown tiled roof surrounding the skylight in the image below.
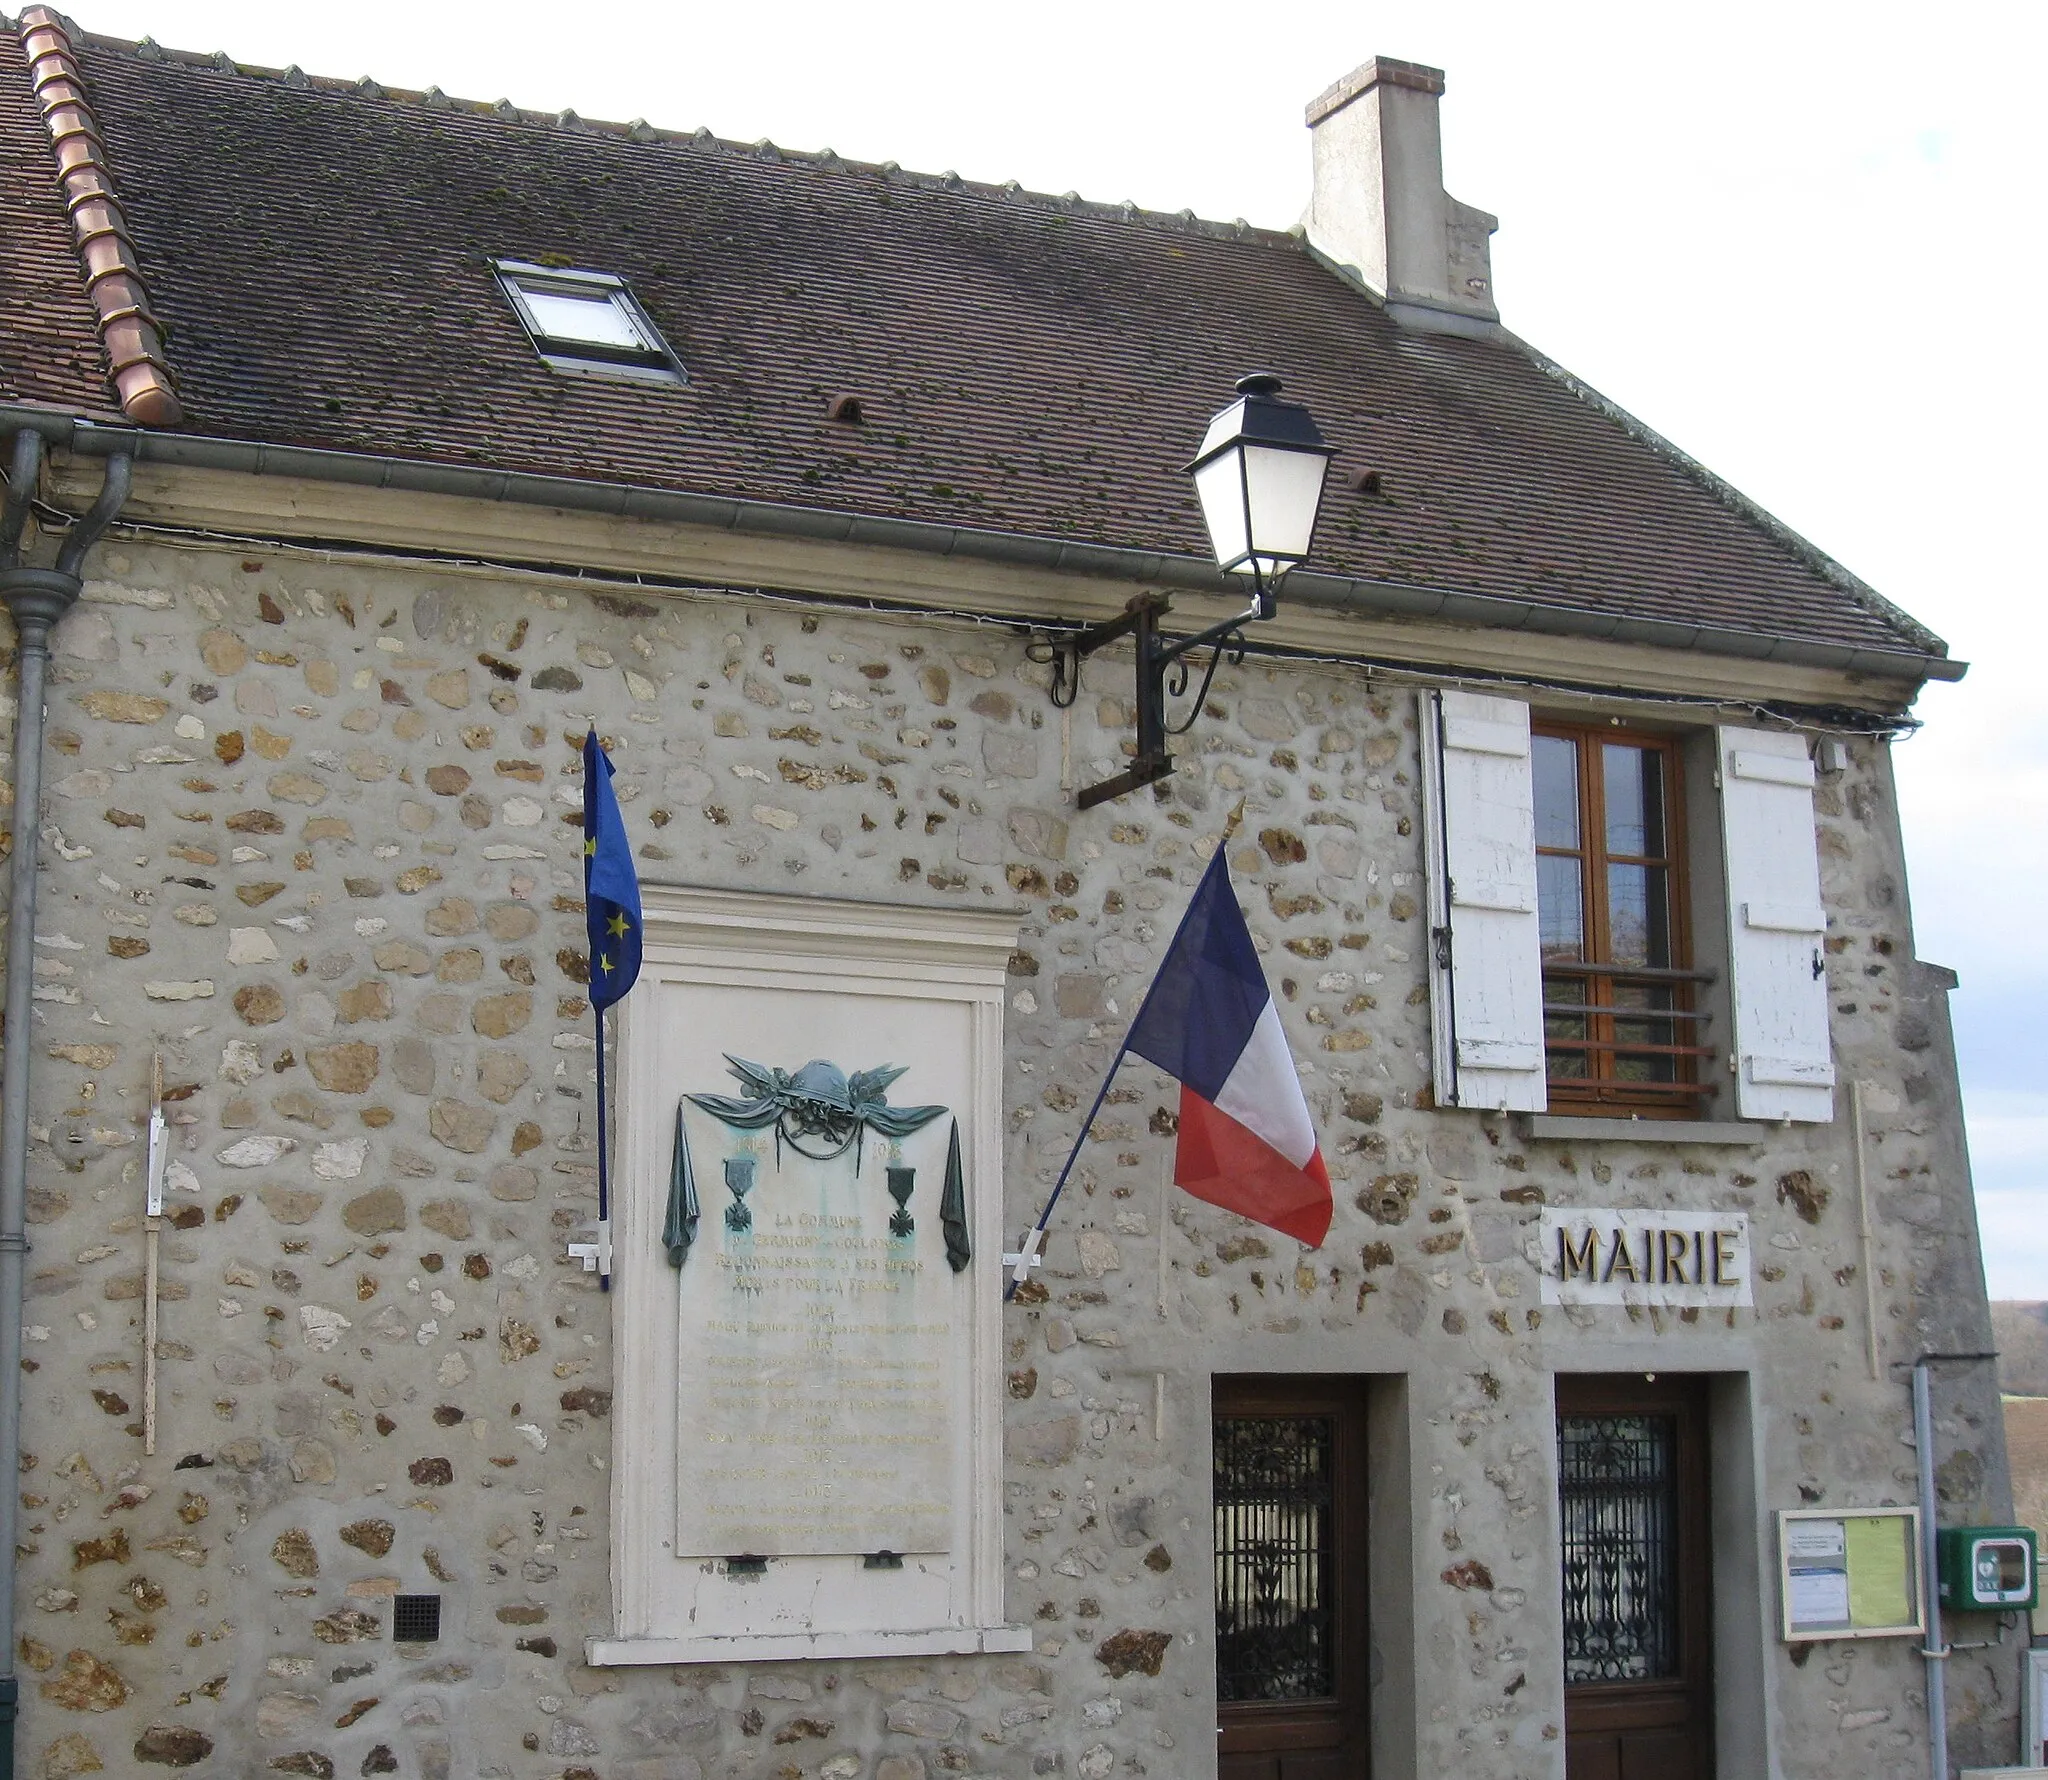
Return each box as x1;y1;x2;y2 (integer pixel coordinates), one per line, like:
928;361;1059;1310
0;19;1942;671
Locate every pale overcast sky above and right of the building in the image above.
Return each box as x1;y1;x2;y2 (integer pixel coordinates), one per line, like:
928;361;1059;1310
56;0;2048;1299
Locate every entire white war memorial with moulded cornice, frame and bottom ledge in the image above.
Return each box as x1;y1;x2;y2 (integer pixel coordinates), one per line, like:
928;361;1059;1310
602;883;1032;1667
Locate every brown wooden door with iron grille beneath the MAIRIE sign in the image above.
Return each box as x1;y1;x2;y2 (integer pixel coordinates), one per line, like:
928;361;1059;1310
1556;1372;1714;1780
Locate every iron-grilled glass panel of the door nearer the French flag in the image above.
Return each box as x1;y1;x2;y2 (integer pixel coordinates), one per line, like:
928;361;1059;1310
1214;1415;1337;1702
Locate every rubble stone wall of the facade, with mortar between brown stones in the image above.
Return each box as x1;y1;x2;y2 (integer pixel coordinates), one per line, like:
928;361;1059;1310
8;543;2017;1780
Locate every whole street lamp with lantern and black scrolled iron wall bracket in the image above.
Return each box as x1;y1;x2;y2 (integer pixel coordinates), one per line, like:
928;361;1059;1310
1053;375;1335;809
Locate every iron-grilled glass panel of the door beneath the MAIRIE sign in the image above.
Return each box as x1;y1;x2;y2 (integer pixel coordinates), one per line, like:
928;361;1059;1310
1556;1415;1679;1682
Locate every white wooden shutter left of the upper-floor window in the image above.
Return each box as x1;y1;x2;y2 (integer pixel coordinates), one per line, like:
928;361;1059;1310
1421;690;1548;1112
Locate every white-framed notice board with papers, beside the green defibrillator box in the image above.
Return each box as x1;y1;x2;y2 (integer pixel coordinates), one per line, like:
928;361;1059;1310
1778;1508;1925;1643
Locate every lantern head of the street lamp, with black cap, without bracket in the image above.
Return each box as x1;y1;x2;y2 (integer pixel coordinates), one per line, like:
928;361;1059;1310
1192;377;1333;580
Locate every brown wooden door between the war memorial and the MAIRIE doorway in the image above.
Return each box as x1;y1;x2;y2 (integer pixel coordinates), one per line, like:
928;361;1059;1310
1214;1379;1368;1780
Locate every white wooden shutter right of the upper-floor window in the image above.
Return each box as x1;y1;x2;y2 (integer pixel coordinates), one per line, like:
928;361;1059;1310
1718;729;1835;1125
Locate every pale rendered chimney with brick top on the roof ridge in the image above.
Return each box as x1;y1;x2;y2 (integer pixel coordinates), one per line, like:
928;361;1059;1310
1307;55;1501;334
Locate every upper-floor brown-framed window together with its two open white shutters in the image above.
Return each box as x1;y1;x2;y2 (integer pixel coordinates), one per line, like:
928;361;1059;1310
1419;686;1835;1137
